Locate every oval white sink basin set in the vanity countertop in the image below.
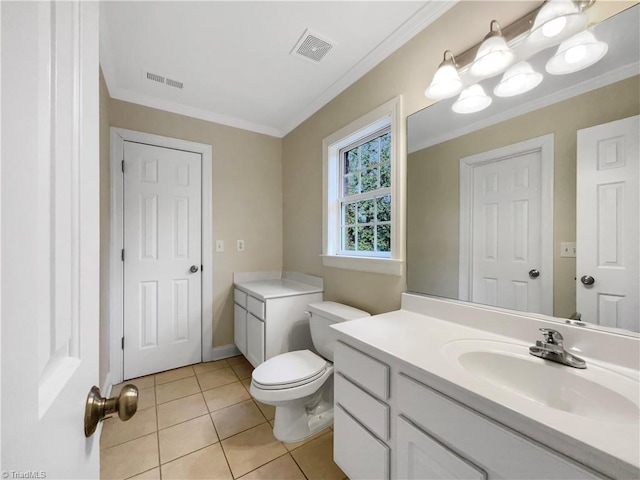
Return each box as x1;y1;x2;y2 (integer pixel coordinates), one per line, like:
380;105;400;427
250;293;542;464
442;340;640;424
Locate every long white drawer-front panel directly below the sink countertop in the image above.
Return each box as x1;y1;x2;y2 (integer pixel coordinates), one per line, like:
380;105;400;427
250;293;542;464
397;374;602;479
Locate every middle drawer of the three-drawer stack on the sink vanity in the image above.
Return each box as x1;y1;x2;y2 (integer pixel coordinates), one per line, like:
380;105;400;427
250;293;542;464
334;373;389;440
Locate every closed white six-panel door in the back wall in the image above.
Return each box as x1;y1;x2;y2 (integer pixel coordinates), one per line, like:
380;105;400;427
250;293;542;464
124;141;202;379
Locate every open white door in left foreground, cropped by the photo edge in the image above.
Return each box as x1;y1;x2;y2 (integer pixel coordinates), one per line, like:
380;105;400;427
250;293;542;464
0;2;100;478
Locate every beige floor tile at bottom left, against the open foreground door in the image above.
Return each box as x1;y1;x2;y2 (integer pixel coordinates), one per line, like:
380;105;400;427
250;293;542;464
100;433;160;480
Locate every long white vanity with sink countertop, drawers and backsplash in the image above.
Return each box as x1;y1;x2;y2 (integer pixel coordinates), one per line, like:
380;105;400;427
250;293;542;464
332;294;640;479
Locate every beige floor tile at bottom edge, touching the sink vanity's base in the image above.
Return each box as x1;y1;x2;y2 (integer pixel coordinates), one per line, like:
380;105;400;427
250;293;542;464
291;432;346;480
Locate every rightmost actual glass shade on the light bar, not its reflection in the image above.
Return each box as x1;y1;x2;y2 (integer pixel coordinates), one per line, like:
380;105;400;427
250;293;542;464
527;0;587;46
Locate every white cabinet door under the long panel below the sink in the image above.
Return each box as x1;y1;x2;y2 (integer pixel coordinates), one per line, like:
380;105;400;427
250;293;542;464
396;417;487;480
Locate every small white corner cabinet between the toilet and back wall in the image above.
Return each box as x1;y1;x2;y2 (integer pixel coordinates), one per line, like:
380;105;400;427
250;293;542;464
233;272;323;367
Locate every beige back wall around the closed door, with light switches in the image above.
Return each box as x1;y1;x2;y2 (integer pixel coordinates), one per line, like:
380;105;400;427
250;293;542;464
103;94;282;347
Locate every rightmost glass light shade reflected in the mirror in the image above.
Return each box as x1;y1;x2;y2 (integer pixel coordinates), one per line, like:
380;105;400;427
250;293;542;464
545;31;609;75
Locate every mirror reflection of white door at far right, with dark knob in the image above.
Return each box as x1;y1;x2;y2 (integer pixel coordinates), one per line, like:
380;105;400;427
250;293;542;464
576;116;640;332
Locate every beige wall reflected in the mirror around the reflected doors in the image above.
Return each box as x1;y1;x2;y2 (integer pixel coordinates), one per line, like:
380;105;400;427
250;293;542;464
407;76;640;317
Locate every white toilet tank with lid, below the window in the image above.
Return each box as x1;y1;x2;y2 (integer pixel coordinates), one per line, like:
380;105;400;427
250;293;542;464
309;302;370;362
